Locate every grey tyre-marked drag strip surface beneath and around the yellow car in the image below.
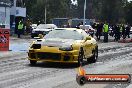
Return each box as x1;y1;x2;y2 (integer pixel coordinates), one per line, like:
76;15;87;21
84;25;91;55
0;44;132;88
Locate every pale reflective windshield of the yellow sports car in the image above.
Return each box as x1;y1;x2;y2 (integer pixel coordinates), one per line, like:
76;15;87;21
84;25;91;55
44;29;84;40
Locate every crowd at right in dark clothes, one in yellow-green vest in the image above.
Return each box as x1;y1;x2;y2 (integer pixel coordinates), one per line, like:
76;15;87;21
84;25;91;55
92;22;131;42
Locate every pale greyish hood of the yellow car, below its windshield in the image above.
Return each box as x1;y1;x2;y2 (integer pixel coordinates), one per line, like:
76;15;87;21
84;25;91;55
36;38;76;47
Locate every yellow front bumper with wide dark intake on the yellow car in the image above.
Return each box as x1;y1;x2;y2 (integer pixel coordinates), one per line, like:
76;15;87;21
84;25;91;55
28;50;79;63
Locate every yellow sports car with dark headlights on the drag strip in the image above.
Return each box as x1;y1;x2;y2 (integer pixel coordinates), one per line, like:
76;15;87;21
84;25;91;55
28;28;98;65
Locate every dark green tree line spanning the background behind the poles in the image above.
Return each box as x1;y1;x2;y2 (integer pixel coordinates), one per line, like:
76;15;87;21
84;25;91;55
25;0;132;23
